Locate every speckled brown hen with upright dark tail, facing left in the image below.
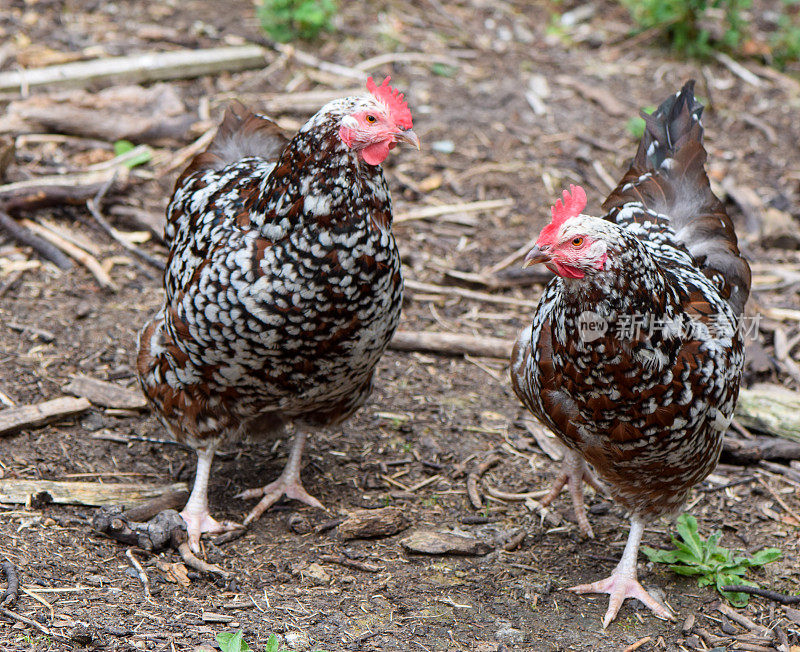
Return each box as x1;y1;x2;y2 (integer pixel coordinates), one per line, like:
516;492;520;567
511;82;750;627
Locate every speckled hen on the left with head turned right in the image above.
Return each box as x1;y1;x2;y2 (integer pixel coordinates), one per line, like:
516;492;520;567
137;78;419;550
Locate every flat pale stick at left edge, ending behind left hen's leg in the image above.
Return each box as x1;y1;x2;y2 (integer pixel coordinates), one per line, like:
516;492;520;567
0;479;186;507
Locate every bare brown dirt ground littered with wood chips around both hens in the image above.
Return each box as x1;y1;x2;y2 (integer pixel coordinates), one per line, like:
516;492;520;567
0;0;800;652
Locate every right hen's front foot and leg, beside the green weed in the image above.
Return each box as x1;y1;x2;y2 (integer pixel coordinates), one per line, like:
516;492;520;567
567;517;675;629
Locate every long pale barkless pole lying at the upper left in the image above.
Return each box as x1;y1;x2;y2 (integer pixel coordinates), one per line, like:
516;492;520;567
0;45;268;92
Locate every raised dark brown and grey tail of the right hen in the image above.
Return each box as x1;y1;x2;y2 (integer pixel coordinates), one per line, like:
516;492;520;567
603;80;750;315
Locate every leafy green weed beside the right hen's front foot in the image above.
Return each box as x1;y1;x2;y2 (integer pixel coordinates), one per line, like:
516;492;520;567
641;514;781;607
